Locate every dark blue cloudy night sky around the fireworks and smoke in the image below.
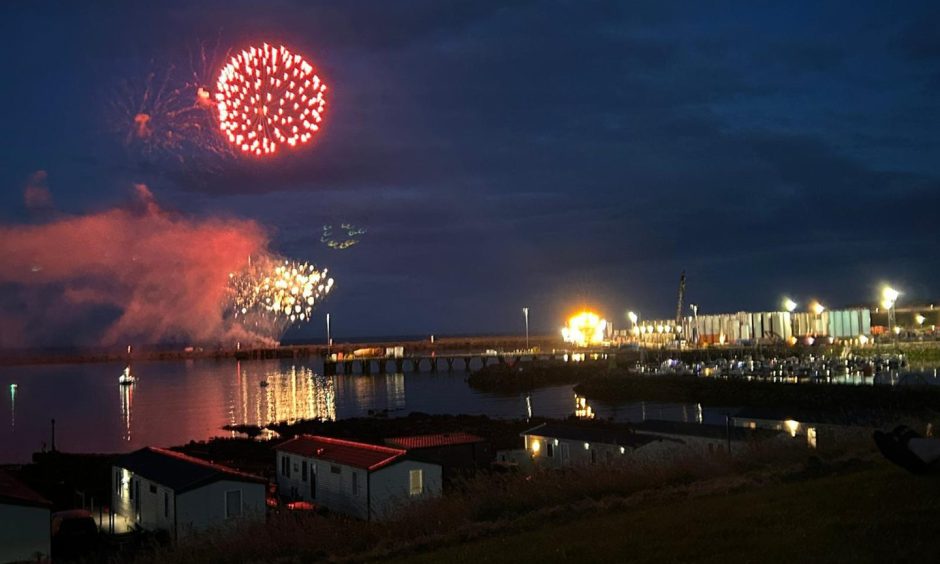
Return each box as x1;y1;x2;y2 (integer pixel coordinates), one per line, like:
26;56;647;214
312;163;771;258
0;0;940;337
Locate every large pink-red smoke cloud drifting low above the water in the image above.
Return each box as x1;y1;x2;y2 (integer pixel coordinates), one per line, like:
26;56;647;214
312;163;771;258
0;185;267;346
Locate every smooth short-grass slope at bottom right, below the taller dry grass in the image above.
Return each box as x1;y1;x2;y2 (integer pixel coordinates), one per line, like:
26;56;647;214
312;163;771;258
392;462;940;564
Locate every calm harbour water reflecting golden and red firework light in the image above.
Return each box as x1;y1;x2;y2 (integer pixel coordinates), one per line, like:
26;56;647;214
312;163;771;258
0;360;725;463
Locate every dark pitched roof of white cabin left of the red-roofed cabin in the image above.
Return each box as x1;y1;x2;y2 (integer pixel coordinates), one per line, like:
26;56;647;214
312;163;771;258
114;447;268;493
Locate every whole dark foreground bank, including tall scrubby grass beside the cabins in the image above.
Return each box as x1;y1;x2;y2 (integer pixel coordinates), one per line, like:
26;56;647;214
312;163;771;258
117;443;940;564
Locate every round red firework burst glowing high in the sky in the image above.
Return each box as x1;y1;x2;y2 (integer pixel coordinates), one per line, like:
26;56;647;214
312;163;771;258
216;44;326;155
